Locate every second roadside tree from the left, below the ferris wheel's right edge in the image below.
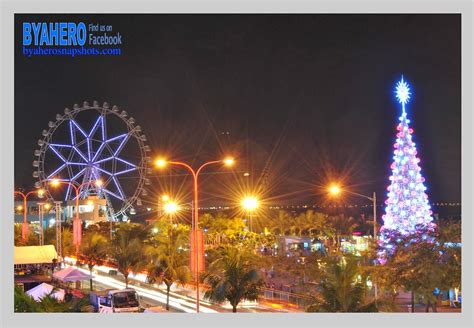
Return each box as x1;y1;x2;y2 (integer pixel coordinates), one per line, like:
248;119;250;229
109;225;145;288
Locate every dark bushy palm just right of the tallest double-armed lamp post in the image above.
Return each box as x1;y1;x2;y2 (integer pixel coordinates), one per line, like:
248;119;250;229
204;246;262;313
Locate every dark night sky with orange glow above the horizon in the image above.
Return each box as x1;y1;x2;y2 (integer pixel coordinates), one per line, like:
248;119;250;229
15;15;461;209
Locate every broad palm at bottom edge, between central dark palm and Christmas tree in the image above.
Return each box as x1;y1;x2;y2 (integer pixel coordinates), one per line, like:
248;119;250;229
306;257;377;312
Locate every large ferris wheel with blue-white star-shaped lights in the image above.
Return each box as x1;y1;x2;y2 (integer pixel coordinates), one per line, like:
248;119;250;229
33;101;151;221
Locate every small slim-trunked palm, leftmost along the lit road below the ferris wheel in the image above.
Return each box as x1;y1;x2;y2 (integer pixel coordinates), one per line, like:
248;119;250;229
80;233;107;290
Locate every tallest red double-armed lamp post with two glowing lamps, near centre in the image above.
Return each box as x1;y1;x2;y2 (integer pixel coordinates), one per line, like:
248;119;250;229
155;158;234;313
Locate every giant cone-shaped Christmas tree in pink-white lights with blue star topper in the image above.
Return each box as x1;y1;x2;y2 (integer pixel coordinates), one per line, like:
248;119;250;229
379;76;435;263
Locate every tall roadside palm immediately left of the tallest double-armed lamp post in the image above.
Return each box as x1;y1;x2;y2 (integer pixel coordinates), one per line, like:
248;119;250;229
147;222;191;311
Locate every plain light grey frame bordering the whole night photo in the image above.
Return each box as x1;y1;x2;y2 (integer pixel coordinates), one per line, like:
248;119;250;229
0;0;474;327
